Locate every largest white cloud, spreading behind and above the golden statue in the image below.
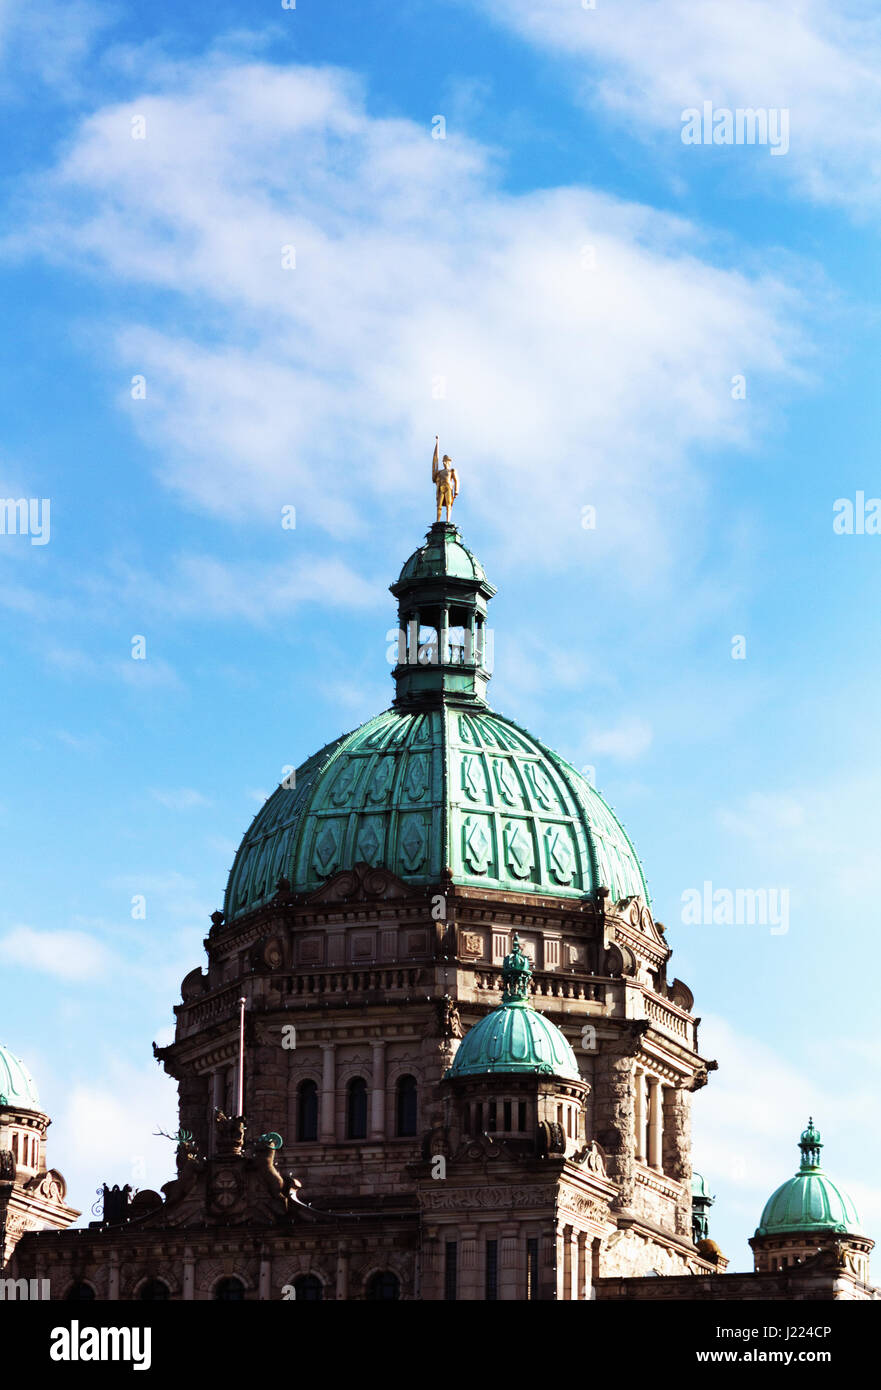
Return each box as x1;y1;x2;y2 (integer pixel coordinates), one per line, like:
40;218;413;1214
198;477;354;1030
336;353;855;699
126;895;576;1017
7;57;803;578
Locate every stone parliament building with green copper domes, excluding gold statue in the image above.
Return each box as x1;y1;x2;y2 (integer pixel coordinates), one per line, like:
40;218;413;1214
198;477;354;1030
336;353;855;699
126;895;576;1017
0;521;881;1301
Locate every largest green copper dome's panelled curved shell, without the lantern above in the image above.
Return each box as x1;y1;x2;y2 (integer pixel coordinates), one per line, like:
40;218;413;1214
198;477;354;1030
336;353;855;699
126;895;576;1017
224;706;649;922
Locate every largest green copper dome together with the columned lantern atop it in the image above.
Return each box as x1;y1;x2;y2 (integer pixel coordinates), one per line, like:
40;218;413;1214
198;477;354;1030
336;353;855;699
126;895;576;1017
224;523;649;922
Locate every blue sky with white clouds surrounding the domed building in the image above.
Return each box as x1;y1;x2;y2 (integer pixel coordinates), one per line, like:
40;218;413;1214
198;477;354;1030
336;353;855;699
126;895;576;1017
0;0;881;1268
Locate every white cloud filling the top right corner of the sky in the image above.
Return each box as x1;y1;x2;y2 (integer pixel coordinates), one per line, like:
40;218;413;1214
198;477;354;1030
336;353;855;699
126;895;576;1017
477;0;881;207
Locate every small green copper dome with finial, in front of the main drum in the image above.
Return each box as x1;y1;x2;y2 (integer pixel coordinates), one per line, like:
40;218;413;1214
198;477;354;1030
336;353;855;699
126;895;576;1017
446;935;581;1081
